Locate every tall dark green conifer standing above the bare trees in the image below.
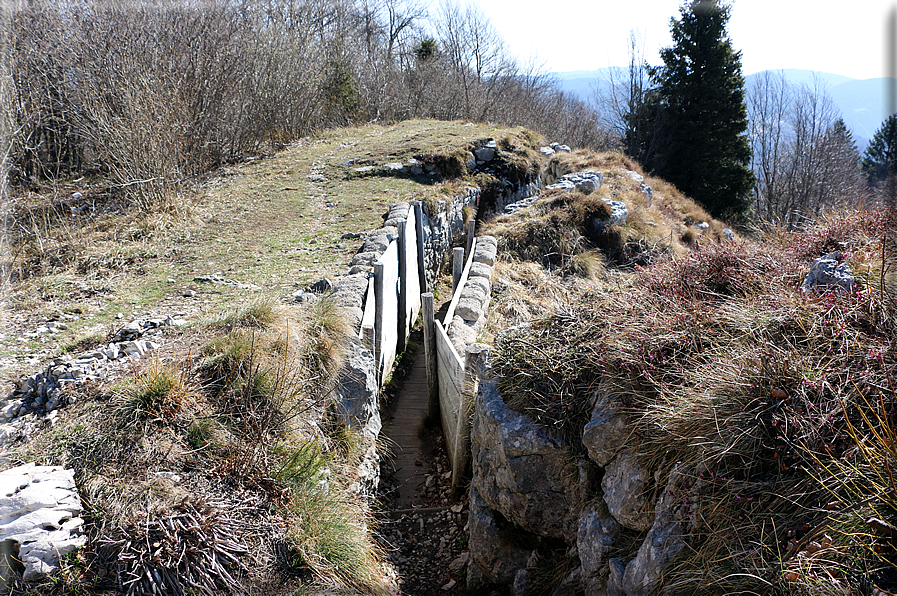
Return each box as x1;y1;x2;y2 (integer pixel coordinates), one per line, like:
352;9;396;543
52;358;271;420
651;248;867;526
653;0;754;217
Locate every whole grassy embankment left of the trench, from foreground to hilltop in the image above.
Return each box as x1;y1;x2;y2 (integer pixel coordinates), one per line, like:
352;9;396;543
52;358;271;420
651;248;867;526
0;121;533;594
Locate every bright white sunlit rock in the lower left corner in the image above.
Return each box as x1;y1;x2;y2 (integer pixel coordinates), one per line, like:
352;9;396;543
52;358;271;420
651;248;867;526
0;463;86;581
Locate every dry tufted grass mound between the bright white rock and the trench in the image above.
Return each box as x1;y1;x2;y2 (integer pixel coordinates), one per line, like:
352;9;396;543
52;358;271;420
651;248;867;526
12;299;391;596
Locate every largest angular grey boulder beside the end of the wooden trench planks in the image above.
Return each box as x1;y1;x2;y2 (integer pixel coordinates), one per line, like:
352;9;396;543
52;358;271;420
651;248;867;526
471;380;578;540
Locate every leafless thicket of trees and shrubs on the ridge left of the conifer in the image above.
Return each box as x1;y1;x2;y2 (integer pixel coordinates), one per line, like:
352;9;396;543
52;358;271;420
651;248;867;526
7;0;620;204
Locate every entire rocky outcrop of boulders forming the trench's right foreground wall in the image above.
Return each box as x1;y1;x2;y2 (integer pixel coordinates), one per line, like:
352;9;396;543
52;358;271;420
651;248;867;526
470;379;701;596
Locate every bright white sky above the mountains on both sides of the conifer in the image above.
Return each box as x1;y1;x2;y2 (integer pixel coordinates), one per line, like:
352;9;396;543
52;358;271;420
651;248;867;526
471;0;897;79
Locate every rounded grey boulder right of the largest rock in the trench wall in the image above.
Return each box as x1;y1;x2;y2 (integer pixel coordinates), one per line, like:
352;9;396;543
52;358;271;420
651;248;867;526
601;449;654;531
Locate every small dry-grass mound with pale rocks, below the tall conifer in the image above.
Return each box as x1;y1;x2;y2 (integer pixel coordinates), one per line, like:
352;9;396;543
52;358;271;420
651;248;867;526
489;150;725;278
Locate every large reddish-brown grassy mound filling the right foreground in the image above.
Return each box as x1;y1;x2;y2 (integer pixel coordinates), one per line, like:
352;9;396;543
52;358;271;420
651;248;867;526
495;212;897;594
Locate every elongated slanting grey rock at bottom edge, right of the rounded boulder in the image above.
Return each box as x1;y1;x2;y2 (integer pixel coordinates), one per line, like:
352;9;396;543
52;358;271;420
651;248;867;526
623;464;700;596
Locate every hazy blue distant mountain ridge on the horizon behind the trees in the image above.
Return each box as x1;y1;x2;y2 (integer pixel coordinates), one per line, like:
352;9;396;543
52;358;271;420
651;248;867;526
554;66;892;151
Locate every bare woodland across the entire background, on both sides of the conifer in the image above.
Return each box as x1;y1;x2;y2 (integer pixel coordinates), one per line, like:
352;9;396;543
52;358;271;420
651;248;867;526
0;0;897;227
